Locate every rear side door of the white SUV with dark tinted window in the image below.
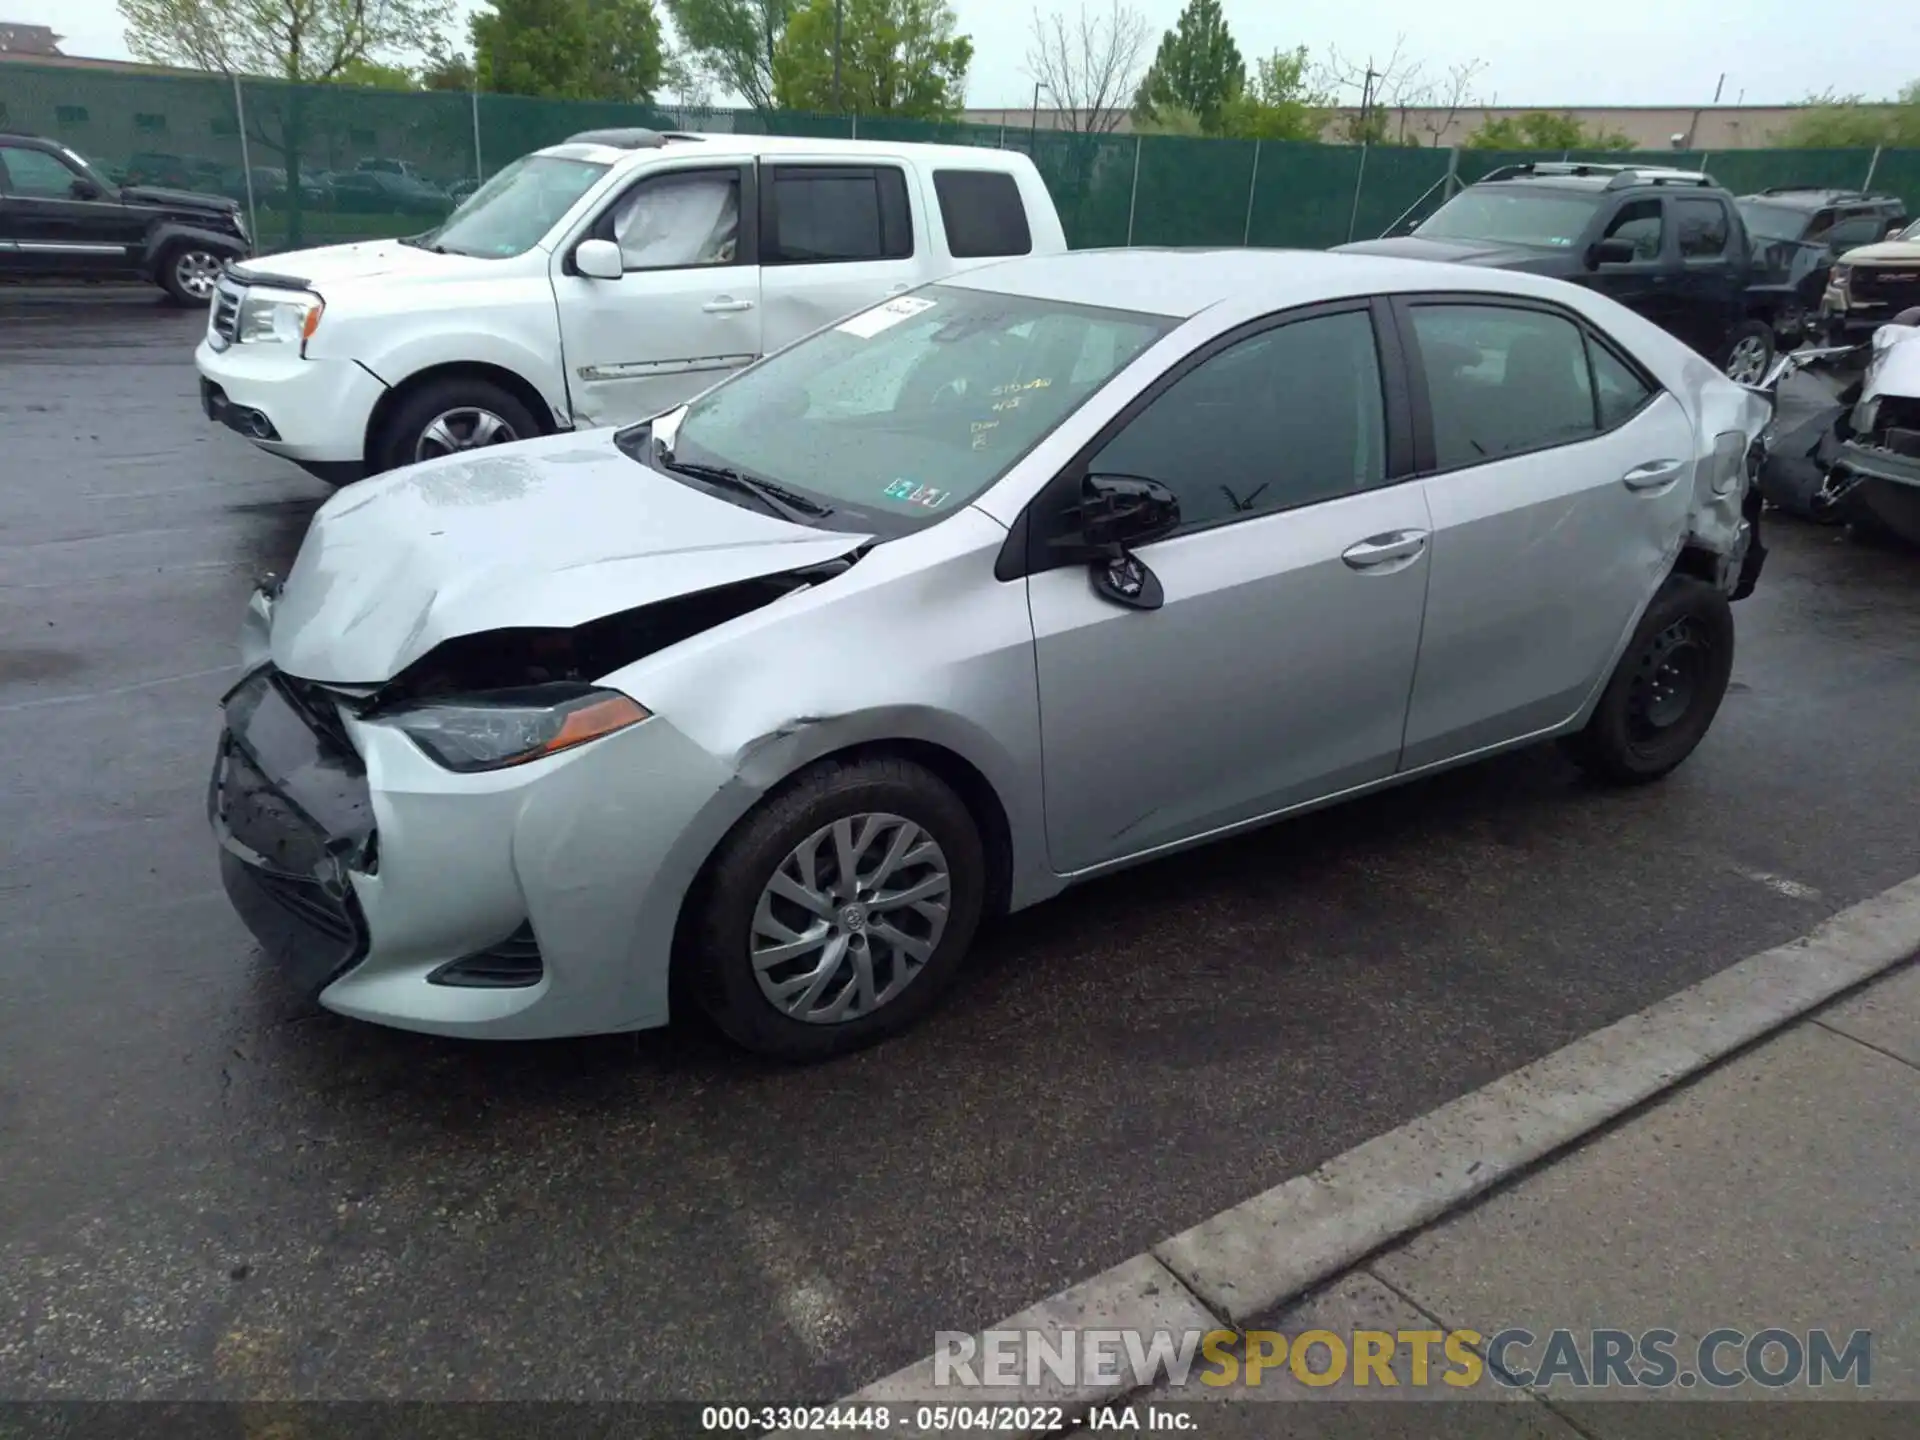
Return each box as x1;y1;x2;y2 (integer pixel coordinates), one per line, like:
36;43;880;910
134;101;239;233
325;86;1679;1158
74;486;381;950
760;161;927;349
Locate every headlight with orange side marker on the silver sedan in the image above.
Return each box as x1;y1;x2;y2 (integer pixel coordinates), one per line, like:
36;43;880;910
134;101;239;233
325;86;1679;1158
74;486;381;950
369;684;651;774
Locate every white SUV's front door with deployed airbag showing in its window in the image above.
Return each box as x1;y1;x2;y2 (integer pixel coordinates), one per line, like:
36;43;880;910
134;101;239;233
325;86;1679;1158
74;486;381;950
553;163;762;426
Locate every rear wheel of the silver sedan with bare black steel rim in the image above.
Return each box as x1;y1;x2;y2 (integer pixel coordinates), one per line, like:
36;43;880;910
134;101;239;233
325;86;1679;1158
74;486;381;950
1563;574;1734;785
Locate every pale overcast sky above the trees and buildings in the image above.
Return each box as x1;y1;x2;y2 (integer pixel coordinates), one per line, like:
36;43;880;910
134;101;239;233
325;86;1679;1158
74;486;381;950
0;0;1920;108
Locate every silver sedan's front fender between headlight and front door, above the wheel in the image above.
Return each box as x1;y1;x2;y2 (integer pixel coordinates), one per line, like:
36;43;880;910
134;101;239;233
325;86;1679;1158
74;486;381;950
603;507;1058;904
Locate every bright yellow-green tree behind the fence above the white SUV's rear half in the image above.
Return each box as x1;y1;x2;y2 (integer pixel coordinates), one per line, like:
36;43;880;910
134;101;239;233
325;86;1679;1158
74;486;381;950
774;0;973;119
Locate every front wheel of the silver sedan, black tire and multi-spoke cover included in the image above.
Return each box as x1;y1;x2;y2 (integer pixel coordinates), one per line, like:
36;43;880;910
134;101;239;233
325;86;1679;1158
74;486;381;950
685;756;987;1062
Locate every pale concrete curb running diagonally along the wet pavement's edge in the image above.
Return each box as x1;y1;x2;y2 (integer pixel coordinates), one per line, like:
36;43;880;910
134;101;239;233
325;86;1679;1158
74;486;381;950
814;876;1920;1434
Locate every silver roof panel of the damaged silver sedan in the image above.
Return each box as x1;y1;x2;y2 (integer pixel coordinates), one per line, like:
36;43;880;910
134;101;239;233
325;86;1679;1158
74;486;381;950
939;248;1612;321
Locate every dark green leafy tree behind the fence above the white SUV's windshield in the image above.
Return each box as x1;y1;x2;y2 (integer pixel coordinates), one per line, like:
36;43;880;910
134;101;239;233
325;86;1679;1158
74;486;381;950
472;0;666;104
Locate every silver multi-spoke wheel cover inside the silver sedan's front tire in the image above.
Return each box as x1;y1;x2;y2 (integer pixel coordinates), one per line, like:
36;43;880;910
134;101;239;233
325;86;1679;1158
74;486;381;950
749;814;952;1025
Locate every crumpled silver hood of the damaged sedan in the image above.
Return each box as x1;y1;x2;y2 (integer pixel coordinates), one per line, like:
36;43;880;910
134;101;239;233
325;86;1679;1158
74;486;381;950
269;430;870;685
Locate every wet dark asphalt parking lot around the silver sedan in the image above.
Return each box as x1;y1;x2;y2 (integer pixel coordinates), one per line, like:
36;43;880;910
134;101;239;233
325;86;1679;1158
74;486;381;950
0;290;1920;1402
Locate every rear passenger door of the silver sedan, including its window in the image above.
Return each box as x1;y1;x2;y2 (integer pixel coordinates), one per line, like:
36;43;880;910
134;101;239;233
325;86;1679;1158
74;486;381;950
1396;296;1695;770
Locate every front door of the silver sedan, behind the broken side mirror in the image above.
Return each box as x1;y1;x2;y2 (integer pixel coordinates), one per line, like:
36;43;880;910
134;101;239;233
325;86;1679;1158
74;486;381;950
1027;301;1430;874
